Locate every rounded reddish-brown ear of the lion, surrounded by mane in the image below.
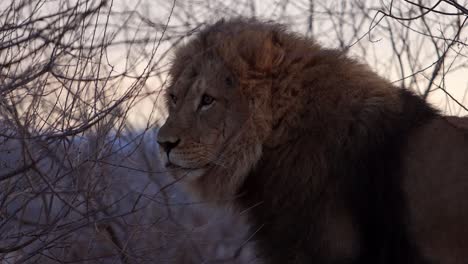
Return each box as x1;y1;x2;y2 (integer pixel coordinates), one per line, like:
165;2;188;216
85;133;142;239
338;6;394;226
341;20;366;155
240;32;284;72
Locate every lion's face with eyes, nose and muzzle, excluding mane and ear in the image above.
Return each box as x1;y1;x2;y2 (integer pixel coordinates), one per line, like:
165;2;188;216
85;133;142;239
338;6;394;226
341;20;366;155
158;54;252;184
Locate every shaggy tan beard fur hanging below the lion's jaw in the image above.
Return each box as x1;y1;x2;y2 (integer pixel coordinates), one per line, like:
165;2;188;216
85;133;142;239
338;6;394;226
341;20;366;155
186;144;262;205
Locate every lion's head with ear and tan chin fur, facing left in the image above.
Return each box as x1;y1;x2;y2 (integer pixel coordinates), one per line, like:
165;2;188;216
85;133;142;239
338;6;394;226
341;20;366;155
158;21;283;200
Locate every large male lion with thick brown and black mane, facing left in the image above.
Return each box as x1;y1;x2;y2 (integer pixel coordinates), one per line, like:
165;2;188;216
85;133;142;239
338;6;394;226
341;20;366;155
158;19;468;264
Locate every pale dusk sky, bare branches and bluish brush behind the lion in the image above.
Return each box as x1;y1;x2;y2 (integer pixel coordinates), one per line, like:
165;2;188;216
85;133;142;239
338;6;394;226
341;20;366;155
0;0;468;264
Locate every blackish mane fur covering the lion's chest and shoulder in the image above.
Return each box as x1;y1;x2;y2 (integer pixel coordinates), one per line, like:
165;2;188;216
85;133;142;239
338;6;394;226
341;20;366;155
239;88;437;264
